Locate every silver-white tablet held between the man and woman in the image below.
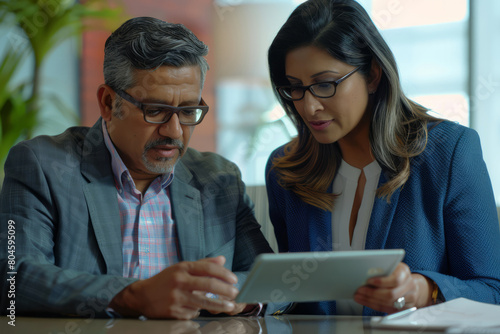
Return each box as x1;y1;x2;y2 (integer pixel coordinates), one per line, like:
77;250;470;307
236;249;405;303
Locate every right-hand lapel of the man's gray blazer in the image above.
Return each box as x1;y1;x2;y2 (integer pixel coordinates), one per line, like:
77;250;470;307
170;159;205;261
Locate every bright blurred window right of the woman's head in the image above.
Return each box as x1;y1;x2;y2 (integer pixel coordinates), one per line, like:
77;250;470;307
366;0;469;126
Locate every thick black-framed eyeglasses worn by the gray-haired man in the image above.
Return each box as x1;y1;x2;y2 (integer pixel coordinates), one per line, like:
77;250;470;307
116;90;208;125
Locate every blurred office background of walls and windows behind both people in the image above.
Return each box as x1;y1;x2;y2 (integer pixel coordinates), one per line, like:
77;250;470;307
0;0;500;211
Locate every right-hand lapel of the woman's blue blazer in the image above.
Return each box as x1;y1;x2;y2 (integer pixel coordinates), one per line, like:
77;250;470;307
365;172;401;249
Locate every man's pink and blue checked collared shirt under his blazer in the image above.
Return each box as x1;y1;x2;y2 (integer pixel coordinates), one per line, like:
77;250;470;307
102;120;179;279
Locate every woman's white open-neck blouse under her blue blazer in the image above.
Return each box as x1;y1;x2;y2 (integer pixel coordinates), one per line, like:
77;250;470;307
332;160;382;315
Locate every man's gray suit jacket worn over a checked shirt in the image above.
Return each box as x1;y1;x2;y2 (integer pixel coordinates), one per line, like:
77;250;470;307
0;120;272;317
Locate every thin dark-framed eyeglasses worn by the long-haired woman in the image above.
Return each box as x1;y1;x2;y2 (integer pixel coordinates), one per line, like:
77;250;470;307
276;66;361;101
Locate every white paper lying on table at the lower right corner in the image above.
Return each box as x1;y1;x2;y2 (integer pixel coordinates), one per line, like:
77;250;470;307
371;298;500;330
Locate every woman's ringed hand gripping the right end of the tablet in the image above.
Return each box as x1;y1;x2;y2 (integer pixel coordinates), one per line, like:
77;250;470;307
354;262;433;313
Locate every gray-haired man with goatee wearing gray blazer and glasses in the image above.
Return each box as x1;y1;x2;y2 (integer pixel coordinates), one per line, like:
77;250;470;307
0;18;272;319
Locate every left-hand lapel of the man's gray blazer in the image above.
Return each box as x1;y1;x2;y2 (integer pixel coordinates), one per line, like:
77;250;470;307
81;118;123;275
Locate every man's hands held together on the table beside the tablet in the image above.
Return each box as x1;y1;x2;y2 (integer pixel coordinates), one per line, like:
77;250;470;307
109;256;239;319
